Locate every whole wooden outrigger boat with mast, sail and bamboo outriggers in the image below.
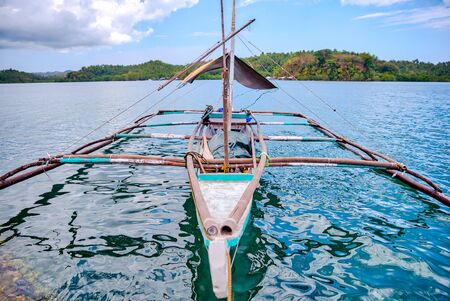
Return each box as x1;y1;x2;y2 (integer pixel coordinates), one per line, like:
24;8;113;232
0;0;450;299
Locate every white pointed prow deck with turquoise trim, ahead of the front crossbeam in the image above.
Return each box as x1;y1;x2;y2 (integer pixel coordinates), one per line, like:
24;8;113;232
193;173;257;298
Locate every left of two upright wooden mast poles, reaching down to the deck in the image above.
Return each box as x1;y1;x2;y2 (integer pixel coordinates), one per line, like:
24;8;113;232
220;0;230;172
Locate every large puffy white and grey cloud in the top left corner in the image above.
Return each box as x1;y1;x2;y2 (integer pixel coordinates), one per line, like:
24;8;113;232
0;0;199;49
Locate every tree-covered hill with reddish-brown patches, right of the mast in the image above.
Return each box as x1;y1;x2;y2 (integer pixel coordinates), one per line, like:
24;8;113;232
247;49;450;81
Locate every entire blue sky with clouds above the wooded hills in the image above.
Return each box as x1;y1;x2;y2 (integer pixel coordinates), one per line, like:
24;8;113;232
0;0;450;72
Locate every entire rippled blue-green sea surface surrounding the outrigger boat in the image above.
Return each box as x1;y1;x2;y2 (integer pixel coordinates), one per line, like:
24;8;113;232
0;81;450;300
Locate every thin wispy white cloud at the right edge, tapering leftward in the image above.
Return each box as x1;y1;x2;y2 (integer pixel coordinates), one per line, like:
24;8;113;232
355;0;450;29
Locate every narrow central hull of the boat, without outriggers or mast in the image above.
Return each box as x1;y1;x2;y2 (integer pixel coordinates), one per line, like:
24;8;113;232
186;109;267;298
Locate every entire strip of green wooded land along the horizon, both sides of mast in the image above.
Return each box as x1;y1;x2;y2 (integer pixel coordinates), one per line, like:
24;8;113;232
0;49;450;83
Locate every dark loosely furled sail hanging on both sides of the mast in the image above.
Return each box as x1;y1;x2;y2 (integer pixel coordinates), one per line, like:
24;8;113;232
183;54;276;90
